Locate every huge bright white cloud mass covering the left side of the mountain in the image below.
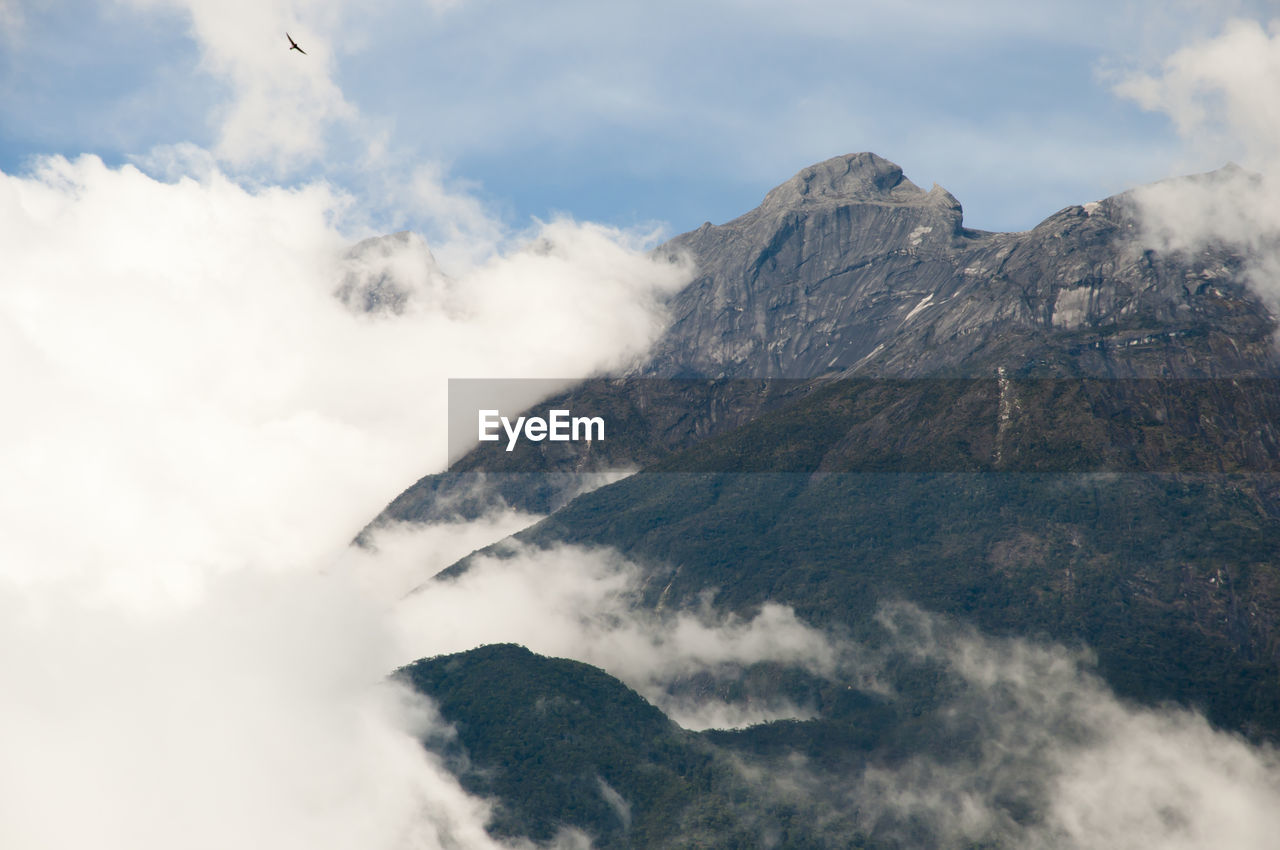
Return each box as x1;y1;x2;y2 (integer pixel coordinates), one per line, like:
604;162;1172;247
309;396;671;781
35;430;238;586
0;148;687;850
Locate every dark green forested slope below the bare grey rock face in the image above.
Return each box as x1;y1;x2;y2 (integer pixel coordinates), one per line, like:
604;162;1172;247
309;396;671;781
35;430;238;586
491;381;1280;737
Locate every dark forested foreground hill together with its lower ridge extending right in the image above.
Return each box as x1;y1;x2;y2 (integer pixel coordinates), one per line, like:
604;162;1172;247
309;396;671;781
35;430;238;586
396;644;1029;850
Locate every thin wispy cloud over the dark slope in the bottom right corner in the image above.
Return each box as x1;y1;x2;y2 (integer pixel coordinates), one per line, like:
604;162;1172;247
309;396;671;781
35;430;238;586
809;605;1280;850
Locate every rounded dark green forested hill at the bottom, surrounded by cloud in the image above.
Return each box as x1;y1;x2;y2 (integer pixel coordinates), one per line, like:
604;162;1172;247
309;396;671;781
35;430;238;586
397;644;881;849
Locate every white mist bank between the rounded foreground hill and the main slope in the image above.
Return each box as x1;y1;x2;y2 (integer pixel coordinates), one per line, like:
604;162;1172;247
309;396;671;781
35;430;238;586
389;540;850;728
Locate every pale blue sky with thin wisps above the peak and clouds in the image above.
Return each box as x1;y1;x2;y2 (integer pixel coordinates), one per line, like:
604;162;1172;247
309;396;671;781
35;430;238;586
0;0;1268;240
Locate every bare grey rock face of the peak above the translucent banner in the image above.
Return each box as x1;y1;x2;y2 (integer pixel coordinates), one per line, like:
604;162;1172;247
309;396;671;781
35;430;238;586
645;154;1276;378
